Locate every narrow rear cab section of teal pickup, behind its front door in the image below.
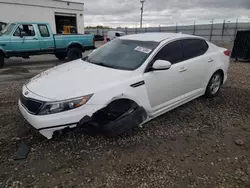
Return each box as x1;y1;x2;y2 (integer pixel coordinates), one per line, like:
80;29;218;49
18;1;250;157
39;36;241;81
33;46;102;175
37;24;55;53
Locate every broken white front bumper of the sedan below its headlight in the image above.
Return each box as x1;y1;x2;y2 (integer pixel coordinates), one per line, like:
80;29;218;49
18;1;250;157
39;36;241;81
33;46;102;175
18;100;103;139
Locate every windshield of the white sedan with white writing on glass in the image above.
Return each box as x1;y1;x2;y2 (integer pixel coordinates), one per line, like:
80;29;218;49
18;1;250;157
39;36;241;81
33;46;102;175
83;38;159;70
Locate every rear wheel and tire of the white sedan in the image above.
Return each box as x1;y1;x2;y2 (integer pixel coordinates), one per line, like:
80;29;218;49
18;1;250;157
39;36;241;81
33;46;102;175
205;71;223;98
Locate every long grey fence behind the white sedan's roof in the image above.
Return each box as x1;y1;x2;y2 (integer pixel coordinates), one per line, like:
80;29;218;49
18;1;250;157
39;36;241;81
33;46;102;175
85;20;250;43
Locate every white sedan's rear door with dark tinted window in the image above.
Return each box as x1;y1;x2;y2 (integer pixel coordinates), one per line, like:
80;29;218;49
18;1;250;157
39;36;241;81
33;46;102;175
182;38;209;98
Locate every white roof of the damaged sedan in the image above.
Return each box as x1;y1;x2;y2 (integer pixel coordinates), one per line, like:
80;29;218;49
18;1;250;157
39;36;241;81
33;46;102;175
120;32;203;42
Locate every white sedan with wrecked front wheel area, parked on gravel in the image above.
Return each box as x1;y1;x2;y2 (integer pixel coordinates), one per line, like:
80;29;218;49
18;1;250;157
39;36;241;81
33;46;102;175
19;33;229;139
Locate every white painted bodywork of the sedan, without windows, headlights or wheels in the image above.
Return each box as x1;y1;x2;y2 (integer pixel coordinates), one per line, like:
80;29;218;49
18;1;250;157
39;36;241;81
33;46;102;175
19;33;229;139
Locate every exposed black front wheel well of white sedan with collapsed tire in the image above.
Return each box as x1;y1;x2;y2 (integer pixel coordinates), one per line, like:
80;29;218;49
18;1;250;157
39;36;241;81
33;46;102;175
87;99;147;136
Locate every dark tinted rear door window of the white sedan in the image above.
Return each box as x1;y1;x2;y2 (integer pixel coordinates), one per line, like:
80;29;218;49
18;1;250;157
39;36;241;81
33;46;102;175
183;39;208;60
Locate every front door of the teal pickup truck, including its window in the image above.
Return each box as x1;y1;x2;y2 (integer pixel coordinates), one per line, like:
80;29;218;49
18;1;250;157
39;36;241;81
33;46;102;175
11;24;40;54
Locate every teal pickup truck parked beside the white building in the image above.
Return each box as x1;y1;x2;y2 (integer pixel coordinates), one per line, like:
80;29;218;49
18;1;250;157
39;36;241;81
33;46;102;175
0;22;95;68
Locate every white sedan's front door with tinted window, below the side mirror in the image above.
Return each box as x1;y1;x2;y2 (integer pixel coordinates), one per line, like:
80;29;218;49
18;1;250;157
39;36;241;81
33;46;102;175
144;40;188;112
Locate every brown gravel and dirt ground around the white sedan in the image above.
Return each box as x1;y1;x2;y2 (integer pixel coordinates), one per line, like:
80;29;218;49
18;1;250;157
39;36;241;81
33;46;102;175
0;58;250;188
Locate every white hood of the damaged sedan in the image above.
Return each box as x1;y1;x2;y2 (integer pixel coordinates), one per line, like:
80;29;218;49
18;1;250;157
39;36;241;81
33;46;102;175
26;60;131;100
